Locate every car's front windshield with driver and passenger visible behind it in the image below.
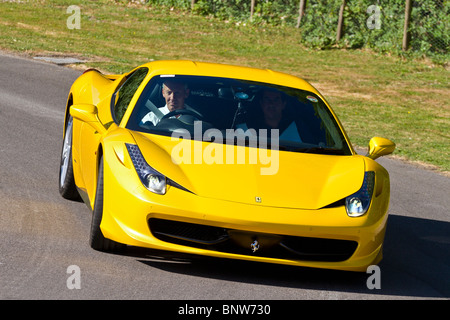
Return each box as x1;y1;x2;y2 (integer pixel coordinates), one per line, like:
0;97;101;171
126;75;351;155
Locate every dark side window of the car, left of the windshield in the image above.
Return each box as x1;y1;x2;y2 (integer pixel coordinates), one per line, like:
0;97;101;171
113;68;148;123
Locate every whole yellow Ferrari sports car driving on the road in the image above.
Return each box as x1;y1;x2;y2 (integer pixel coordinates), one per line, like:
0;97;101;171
59;61;395;271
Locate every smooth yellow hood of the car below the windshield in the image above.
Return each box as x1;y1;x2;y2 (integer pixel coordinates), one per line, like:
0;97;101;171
133;132;365;210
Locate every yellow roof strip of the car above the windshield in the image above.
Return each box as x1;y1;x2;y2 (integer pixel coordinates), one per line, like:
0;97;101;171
141;60;319;94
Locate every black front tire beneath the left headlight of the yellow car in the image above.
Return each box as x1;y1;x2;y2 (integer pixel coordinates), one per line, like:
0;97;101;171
89;157;126;252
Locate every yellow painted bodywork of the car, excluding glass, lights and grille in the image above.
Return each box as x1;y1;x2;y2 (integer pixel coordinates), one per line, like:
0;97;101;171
61;61;396;271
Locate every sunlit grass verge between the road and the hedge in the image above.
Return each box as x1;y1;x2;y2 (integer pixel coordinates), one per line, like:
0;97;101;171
0;0;450;173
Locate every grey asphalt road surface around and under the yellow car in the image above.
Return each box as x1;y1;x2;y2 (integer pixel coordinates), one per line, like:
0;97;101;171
0;53;450;300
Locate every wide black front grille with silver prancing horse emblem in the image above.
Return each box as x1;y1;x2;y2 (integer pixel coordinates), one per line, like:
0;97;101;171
148;218;358;262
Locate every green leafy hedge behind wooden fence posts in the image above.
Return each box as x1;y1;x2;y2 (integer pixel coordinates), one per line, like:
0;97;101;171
147;0;450;62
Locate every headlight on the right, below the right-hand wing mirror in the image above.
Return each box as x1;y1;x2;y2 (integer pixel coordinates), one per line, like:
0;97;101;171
345;171;375;217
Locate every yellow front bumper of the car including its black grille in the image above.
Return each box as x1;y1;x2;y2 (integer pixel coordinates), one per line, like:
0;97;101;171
100;152;387;272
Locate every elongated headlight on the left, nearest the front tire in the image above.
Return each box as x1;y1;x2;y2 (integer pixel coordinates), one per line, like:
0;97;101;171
126;143;167;194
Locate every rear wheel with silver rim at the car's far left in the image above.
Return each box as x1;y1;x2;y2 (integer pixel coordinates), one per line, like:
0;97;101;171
58;116;80;200
